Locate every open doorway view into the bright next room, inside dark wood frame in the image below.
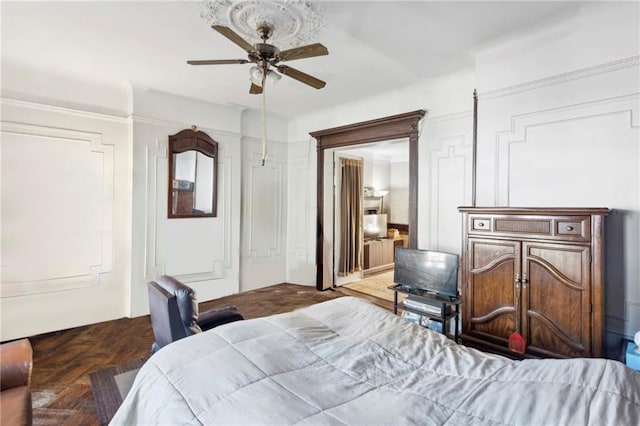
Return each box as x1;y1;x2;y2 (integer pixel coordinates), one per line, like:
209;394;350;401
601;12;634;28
332;138;409;295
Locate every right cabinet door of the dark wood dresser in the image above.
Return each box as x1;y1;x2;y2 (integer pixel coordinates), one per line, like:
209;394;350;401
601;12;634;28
522;242;592;357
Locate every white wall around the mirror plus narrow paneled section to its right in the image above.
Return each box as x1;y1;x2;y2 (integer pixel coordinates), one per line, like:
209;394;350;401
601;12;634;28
131;90;287;315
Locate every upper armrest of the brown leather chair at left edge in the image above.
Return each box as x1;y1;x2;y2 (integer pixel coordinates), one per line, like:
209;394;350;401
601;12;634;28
0;339;33;390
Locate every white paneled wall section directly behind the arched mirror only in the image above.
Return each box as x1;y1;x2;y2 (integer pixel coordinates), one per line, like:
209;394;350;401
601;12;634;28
130;89;242;316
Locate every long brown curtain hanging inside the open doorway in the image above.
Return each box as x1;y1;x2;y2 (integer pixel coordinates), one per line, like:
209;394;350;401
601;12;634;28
338;158;363;276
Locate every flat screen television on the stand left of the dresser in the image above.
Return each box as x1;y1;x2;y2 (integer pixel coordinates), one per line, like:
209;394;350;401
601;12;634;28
393;247;458;298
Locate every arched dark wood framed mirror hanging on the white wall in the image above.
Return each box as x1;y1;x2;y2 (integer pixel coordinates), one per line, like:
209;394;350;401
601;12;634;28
167;126;218;219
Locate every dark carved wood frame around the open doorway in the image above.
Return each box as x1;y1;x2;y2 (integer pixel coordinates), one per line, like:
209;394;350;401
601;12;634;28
309;110;427;290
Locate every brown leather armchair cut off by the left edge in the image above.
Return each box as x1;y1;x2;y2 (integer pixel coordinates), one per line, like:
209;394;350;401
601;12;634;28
0;339;33;425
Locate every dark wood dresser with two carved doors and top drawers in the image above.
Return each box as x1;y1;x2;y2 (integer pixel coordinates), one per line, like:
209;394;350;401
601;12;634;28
458;207;609;358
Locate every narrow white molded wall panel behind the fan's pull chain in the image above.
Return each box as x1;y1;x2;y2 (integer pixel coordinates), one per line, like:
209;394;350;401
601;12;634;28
244;150;285;263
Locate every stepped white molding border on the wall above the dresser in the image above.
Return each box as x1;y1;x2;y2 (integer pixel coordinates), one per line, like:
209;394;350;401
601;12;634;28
495;93;640;206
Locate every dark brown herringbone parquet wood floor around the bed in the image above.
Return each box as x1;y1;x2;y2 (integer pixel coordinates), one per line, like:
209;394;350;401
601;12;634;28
30;284;392;426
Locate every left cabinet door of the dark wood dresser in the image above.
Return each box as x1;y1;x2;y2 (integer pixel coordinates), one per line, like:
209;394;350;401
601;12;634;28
463;238;521;347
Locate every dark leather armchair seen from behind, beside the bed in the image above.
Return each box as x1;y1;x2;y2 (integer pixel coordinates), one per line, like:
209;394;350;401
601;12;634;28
147;275;244;353
